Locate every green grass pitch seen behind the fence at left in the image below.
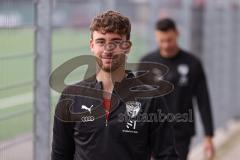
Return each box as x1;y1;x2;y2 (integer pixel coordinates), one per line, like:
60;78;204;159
0;29;146;141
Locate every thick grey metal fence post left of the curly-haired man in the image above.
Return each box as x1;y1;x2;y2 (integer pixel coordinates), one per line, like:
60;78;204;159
34;0;52;160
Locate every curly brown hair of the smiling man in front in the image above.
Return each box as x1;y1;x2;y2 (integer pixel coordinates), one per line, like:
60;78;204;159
90;11;131;40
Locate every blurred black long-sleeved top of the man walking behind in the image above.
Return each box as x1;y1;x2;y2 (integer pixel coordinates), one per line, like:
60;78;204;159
140;49;213;139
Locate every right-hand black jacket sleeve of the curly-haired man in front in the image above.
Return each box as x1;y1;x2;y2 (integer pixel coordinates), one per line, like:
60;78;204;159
150;98;179;160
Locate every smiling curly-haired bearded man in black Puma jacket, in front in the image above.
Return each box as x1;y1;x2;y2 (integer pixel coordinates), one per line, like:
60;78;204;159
51;11;178;160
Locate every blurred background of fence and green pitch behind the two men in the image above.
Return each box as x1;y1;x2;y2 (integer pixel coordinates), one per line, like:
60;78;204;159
0;0;240;160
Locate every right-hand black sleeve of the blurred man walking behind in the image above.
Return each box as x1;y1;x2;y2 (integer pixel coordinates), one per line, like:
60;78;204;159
194;62;214;136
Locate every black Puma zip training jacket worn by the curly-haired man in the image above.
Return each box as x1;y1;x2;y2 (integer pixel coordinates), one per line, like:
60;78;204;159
51;73;178;160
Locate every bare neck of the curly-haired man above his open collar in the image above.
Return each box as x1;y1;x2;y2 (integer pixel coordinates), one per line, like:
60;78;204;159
96;68;125;99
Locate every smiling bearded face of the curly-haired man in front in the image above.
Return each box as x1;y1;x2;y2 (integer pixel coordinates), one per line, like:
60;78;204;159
90;31;131;72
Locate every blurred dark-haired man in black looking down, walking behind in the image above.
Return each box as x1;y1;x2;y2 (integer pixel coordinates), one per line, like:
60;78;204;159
140;18;214;160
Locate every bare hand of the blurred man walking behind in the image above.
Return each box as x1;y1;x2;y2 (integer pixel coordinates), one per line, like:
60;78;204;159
203;136;215;160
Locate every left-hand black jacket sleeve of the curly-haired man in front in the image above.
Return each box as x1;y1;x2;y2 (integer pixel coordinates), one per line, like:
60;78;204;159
51;96;75;160
